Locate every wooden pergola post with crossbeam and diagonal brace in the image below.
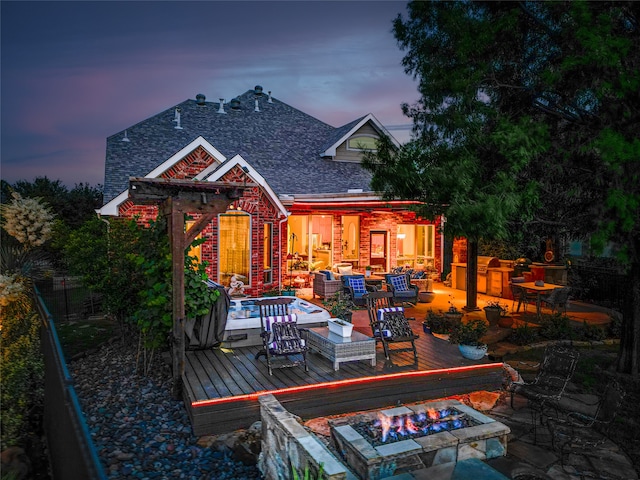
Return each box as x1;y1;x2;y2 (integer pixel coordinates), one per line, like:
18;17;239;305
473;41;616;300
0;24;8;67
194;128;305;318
129;178;249;399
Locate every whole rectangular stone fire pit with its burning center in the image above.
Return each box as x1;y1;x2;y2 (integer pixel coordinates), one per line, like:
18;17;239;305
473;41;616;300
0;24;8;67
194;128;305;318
329;400;510;480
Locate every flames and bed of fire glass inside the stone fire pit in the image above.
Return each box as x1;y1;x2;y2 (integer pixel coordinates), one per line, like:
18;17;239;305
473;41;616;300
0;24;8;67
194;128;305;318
364;408;473;444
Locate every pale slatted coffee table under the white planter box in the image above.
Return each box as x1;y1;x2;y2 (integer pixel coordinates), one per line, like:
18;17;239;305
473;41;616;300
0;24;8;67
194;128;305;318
307;327;376;371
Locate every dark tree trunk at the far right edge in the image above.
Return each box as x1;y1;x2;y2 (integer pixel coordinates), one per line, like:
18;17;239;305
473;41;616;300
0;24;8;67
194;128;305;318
617;262;640;377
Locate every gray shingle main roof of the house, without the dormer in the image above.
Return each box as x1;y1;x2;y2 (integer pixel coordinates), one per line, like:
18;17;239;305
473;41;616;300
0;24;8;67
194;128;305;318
104;90;378;203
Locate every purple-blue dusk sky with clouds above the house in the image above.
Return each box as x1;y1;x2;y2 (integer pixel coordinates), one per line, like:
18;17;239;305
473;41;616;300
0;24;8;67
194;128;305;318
0;0;418;187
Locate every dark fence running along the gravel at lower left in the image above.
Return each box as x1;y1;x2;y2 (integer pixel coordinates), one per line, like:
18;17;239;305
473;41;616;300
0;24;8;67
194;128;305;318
35;287;107;480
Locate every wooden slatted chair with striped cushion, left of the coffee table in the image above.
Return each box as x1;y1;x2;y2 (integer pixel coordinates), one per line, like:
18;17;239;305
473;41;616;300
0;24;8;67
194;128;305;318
255;298;309;375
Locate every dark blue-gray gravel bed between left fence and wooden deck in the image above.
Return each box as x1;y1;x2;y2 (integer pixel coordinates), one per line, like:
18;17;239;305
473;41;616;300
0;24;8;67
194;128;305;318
69;342;262;480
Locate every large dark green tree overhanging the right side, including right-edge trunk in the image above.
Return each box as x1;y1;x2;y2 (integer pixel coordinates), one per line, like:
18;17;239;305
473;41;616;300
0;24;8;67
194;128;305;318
366;1;640;374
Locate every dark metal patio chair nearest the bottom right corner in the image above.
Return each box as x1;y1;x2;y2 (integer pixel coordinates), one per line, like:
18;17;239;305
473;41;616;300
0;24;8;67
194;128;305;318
547;379;625;478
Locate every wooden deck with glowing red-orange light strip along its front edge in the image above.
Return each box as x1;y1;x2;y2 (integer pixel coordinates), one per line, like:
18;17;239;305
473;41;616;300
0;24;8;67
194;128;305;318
183;322;502;435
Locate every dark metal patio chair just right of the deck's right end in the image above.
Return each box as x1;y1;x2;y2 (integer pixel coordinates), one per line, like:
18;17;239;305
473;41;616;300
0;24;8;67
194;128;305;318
508;345;580;442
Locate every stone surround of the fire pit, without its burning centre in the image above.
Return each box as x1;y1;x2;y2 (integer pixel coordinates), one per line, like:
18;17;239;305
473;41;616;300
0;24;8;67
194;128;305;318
329;400;510;480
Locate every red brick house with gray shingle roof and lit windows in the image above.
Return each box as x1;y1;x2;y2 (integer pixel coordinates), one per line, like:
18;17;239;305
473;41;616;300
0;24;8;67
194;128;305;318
99;86;443;296
